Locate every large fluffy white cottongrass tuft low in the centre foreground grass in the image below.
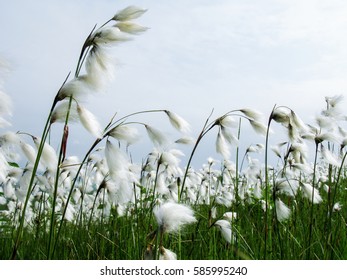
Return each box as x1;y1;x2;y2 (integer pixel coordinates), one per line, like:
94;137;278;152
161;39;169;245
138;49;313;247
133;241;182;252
154;201;196;233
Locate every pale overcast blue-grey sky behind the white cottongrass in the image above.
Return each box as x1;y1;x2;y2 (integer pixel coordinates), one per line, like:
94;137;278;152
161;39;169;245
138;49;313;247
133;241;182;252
0;0;347;166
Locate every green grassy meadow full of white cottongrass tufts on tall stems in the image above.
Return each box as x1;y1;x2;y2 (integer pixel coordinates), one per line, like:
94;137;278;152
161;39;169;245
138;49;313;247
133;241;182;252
0;6;347;260
